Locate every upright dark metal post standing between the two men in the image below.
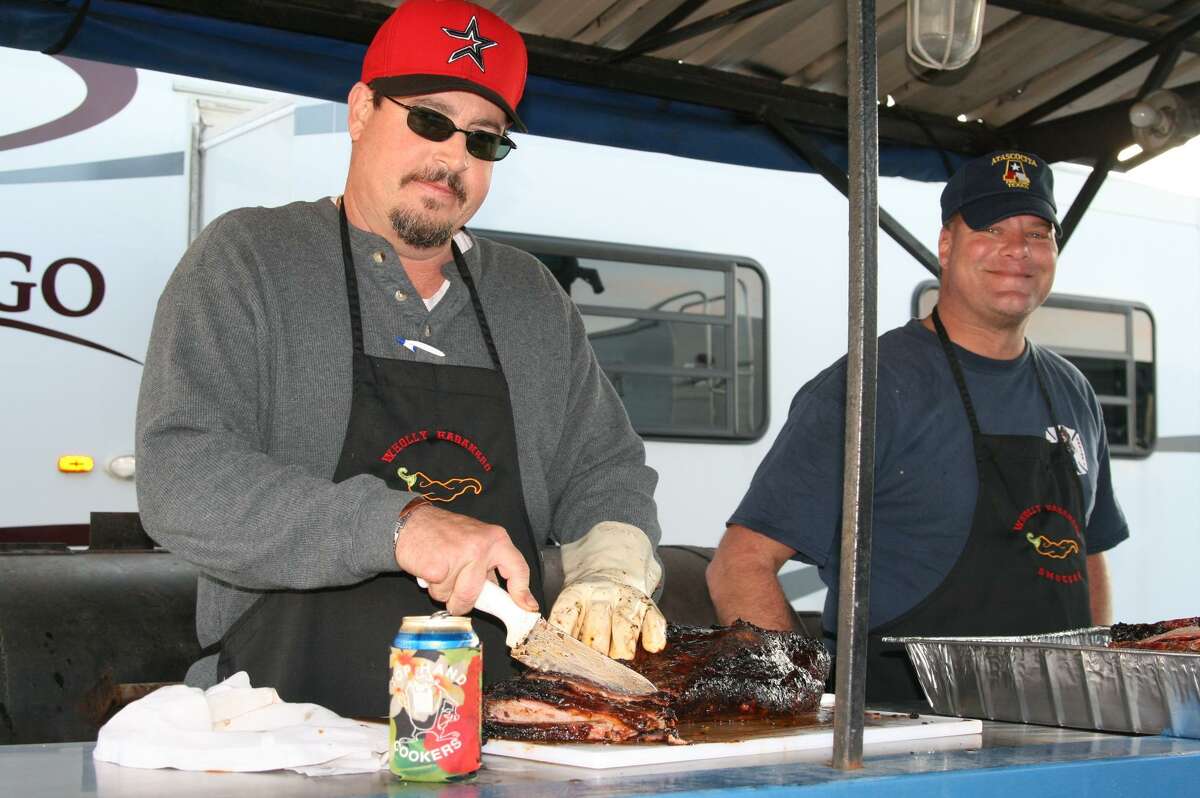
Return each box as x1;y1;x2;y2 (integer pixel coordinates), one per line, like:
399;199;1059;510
833;0;880;770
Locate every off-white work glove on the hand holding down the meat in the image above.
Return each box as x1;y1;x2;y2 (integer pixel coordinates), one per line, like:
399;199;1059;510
550;521;667;660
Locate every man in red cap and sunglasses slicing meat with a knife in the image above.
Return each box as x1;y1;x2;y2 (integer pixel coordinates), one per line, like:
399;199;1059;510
138;0;665;716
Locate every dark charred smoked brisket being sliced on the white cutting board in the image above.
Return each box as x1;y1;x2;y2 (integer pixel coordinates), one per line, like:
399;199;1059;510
484;620;829;742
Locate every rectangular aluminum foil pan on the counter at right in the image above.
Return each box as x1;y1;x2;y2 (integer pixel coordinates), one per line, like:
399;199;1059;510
886;626;1200;738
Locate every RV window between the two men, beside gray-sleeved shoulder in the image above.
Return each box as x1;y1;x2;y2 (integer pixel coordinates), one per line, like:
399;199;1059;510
479;230;767;440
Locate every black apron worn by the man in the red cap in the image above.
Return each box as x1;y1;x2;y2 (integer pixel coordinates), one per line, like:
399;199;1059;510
217;208;545;718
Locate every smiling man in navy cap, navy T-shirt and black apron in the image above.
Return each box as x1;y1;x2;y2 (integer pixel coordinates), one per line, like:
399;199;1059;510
708;151;1129;702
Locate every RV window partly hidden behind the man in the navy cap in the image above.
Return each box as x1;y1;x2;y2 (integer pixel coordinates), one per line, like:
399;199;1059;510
913;281;1156;457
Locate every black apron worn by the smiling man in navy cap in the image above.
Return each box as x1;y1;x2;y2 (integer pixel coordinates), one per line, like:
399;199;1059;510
826;307;1092;703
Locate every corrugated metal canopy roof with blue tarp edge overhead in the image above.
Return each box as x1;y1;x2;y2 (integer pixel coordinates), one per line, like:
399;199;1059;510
9;0;1200;180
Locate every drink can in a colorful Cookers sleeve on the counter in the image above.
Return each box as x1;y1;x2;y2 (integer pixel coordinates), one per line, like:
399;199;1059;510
388;612;484;781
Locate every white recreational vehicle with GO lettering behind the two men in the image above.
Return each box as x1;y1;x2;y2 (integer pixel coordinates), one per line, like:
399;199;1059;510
0;50;1200;618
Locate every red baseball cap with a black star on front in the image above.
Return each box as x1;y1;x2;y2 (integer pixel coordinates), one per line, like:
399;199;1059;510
362;0;529;133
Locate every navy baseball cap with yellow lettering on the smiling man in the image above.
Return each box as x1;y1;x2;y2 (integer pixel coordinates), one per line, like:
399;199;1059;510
942;150;1062;235
